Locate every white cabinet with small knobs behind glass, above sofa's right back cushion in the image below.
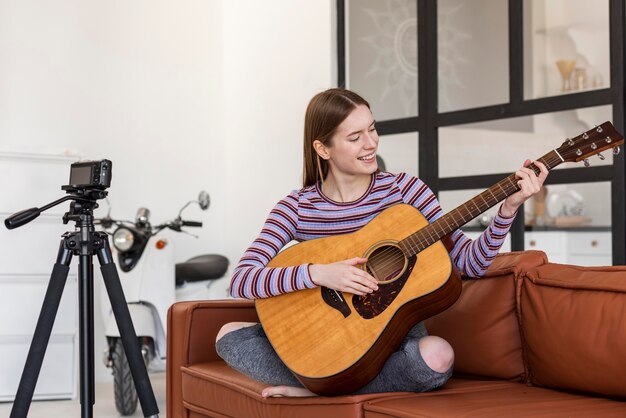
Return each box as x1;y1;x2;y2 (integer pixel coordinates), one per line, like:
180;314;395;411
524;230;613;266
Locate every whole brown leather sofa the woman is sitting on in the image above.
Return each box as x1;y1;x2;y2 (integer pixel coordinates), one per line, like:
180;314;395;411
167;251;626;418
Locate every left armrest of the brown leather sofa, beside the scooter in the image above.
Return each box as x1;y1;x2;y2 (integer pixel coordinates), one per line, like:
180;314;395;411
166;299;259;417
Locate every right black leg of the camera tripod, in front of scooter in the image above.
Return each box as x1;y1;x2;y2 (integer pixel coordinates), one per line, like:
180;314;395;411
98;235;159;417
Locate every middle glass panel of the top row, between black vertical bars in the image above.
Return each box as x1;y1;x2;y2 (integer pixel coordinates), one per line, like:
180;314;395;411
437;0;509;112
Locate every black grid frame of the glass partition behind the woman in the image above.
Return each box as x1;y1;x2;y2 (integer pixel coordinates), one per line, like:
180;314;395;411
337;0;626;265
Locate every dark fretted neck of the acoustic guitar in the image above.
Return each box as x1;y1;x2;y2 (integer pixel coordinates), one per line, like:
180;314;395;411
400;150;564;256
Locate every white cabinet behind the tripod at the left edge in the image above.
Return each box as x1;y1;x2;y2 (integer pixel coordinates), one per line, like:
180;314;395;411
0;153;78;401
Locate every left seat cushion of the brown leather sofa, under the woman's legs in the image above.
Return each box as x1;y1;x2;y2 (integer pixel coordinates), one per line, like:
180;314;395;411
181;361;407;418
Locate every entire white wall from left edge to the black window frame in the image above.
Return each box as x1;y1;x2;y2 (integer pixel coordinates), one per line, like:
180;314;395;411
0;0;336;380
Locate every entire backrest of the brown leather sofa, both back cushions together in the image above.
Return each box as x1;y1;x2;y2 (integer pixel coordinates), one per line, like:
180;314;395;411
426;251;626;399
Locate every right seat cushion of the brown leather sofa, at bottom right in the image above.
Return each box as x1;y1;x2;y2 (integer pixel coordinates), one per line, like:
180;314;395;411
363;378;626;418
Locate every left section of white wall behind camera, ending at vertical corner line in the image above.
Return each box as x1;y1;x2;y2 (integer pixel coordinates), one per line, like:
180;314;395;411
0;0;223;251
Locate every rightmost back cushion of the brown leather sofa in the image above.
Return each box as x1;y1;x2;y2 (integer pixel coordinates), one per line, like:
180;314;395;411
521;264;626;398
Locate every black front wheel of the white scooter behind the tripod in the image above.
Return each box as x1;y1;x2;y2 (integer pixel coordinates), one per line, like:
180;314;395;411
111;338;137;415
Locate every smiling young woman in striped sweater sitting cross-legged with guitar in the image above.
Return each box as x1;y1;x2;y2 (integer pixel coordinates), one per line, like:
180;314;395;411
216;89;548;397
